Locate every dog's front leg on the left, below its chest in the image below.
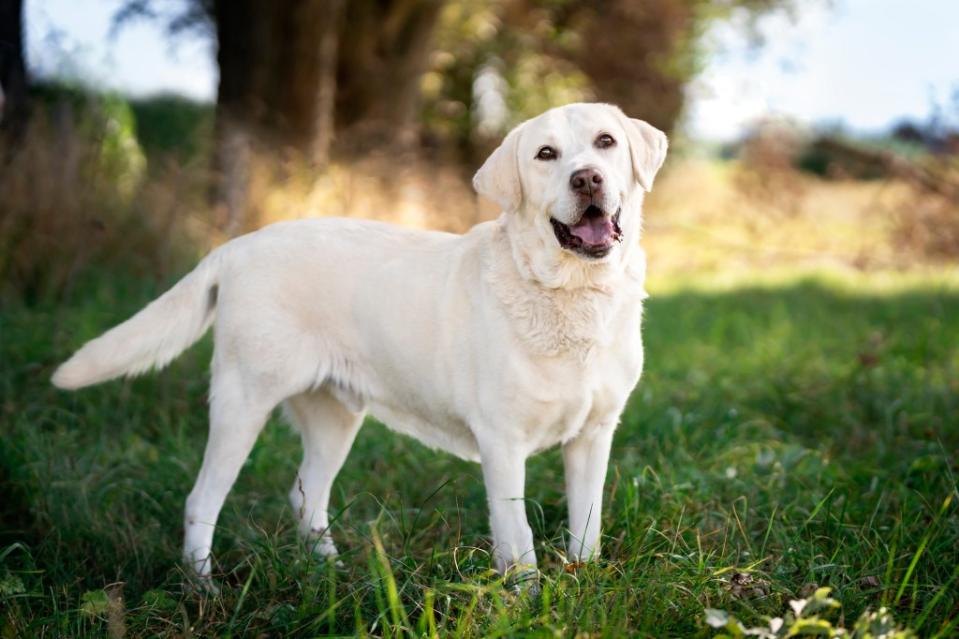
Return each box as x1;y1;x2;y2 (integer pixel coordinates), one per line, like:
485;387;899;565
480;441;536;577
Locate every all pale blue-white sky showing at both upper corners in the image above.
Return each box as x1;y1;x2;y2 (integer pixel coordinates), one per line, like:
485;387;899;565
26;0;959;140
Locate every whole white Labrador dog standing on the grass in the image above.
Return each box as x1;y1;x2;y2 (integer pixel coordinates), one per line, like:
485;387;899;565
53;104;667;580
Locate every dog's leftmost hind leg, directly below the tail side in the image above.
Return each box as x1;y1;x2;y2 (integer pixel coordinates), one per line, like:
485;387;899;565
183;380;275;587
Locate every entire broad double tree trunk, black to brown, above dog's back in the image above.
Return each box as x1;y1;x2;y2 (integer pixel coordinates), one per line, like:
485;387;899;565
213;0;443;233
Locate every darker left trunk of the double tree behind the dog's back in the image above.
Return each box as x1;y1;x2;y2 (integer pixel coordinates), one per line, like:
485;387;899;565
214;0;342;233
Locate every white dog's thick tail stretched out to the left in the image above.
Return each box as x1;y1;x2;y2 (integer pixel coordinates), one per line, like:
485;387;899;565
51;251;221;390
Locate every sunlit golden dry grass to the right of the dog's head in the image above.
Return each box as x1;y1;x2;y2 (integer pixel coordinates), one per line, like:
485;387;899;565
644;161;959;278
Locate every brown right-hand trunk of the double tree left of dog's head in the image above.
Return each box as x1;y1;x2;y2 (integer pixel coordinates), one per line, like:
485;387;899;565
336;0;443;153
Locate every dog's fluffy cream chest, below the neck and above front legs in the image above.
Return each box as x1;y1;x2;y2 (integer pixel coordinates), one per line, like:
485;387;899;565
476;238;646;452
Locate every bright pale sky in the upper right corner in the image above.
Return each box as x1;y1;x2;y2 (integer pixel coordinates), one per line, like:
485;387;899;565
689;0;959;137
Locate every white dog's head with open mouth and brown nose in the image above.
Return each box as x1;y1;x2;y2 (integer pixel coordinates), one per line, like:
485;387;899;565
473;104;667;276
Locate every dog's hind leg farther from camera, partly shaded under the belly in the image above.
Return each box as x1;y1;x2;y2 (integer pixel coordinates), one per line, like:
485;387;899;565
286;389;363;556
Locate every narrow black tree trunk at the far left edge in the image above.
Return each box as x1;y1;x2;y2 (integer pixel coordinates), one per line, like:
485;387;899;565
0;0;30;145
